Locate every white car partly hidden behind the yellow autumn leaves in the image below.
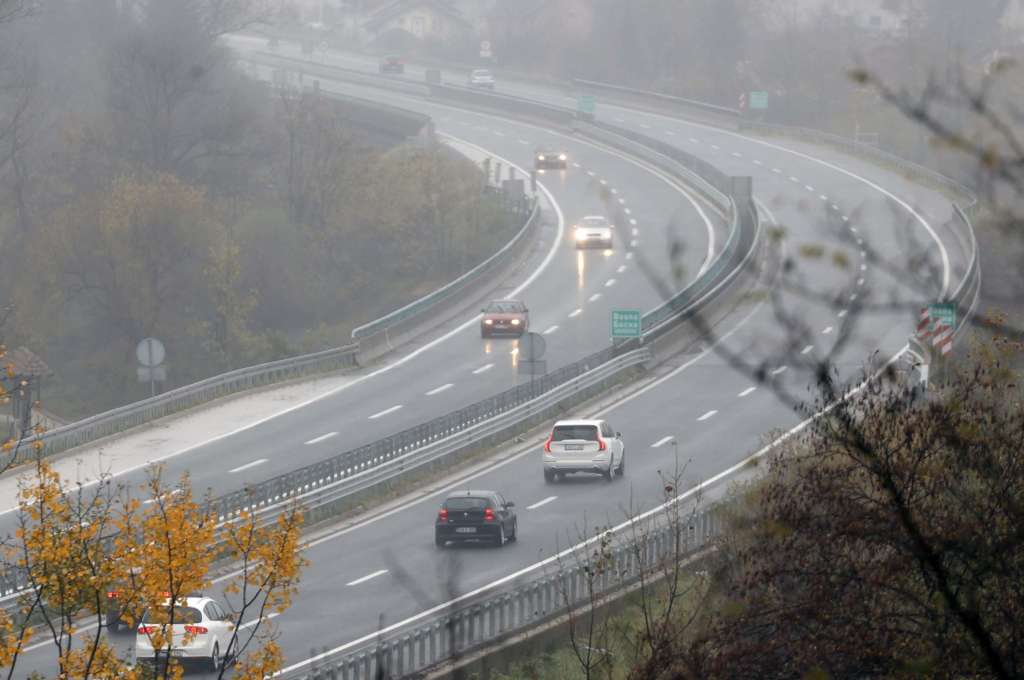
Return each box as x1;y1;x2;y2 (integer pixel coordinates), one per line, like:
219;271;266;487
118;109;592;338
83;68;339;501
135;597;234;671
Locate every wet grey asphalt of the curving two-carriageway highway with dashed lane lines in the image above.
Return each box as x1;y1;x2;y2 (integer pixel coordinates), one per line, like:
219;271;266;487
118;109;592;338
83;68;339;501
6;38;959;677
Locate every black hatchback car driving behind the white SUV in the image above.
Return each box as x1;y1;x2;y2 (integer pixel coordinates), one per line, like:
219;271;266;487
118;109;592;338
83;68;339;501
434;491;518;548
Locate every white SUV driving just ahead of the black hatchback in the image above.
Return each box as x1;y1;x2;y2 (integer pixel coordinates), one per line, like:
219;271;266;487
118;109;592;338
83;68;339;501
544;420;626;483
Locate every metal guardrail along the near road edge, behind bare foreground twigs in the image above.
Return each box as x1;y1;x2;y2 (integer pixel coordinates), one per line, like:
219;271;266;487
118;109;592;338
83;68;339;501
274;501;721;680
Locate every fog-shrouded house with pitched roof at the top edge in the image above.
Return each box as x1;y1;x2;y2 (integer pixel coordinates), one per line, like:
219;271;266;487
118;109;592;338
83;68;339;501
361;0;475;41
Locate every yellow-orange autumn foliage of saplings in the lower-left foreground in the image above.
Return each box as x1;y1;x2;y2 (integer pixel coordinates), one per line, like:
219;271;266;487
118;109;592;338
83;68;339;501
0;461;305;680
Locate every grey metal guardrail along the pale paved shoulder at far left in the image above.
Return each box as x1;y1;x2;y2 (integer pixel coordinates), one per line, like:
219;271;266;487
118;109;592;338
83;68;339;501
14;345;358;464
